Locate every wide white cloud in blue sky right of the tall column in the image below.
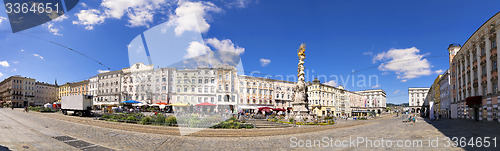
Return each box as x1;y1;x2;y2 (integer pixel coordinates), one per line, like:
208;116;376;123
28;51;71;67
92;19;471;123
373;47;432;82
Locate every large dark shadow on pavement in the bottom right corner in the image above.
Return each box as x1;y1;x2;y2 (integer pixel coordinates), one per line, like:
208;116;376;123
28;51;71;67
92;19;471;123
424;119;500;150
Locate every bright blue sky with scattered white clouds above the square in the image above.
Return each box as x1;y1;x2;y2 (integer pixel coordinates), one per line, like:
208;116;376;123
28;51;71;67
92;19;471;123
0;0;500;103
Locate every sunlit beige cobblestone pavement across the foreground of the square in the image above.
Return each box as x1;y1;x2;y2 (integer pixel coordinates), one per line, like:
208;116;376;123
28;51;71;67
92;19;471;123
0;109;500;150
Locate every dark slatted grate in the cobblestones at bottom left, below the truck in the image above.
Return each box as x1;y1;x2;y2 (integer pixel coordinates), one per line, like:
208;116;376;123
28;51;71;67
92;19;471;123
52;136;112;151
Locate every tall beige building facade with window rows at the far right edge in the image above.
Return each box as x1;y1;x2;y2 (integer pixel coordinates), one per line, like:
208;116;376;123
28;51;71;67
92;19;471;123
448;13;500;121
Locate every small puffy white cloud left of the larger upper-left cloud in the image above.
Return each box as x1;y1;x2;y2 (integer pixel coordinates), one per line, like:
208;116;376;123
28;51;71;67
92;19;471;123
73;9;106;30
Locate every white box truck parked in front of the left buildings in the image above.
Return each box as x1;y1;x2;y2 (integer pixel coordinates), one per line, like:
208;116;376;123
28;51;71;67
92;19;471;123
61;95;93;116
